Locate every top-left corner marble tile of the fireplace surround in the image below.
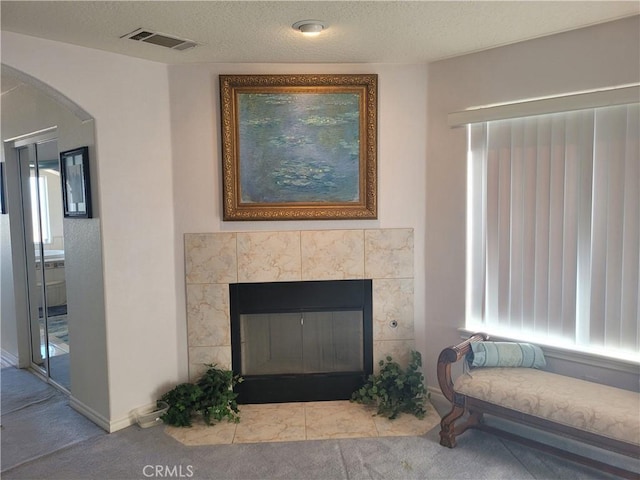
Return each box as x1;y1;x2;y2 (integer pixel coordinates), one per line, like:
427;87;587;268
184;233;238;284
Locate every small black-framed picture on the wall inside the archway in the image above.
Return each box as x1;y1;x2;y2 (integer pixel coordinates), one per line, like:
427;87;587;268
60;147;91;218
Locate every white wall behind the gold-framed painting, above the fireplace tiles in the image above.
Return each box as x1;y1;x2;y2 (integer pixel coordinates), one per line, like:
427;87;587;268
169;64;435;382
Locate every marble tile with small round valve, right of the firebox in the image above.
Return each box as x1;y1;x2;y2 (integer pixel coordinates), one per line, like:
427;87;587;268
373;278;415;340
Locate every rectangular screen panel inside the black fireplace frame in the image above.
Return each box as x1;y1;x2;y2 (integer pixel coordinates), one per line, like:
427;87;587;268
240;311;364;375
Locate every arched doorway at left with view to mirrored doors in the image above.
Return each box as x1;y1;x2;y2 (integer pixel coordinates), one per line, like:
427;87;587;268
0;65;99;395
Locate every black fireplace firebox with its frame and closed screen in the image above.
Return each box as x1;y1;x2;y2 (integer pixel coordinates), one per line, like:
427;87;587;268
229;280;373;404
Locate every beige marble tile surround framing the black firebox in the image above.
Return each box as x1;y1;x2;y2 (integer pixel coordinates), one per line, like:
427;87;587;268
184;228;415;381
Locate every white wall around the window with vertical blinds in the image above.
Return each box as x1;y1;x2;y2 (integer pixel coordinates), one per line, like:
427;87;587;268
425;17;640;388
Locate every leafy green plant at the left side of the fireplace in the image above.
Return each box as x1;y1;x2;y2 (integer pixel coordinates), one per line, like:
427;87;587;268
160;365;242;427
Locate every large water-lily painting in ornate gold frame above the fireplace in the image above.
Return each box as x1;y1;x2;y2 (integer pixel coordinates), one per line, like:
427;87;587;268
220;74;378;220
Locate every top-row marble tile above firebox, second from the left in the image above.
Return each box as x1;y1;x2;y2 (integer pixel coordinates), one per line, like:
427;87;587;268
237;231;302;282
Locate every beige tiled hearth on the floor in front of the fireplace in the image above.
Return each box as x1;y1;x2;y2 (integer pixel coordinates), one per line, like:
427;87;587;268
165;401;440;445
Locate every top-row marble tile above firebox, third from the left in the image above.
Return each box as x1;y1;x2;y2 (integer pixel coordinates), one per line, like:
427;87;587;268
300;230;364;280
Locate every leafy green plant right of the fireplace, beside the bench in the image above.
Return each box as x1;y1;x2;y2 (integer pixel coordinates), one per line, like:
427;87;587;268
351;350;429;420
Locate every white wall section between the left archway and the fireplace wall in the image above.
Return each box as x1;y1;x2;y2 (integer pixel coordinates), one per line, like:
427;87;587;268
2;32;180;429
